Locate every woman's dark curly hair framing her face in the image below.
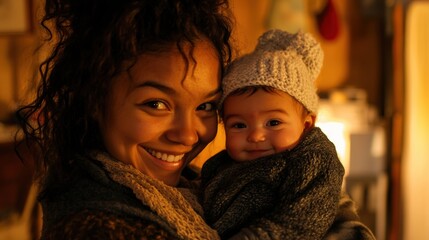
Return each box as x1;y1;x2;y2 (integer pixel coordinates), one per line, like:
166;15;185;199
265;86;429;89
18;0;232;191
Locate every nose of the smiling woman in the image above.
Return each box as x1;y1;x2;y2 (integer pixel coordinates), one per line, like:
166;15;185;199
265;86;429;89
166;113;199;146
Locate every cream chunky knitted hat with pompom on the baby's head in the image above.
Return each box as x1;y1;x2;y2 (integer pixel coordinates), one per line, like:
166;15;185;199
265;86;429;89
221;30;323;113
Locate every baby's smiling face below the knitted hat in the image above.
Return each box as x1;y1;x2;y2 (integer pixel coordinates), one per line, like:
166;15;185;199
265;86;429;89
223;90;315;161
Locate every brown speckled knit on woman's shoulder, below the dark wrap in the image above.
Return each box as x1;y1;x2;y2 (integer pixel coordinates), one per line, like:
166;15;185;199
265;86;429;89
42;209;177;240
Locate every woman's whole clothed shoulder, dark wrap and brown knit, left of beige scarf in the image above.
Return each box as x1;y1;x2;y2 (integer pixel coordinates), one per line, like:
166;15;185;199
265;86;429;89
39;156;180;240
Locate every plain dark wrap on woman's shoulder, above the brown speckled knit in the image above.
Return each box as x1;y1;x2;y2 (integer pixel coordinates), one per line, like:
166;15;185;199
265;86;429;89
39;155;169;233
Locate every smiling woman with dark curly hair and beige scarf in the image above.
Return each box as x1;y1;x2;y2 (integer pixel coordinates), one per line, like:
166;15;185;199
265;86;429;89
20;0;231;239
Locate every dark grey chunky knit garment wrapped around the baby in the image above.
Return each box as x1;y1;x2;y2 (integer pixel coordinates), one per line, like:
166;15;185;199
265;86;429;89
201;128;344;239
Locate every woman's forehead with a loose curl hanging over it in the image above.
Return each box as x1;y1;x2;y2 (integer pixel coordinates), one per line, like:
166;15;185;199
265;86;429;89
108;39;221;99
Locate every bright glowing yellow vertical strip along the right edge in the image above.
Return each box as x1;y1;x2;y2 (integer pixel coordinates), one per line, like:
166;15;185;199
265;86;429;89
401;1;429;239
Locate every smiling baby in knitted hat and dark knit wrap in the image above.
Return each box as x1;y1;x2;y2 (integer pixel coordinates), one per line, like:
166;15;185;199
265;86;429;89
202;30;344;239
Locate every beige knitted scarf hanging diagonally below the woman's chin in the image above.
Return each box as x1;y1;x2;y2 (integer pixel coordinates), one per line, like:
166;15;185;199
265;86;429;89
93;152;220;240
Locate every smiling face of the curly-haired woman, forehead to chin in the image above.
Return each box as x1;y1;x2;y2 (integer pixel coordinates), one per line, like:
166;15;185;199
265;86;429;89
100;41;221;186
